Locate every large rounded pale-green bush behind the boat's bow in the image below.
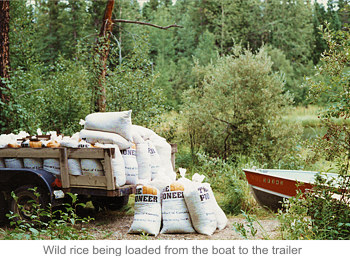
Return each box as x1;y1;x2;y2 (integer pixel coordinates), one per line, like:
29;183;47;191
183;47;296;163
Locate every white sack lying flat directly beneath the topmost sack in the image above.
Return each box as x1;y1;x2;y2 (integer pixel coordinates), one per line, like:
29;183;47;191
79;129;131;150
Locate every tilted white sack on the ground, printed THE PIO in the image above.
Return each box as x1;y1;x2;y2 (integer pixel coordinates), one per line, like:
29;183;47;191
184;182;217;236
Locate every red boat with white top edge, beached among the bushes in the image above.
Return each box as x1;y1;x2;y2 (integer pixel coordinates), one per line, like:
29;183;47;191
243;168;338;211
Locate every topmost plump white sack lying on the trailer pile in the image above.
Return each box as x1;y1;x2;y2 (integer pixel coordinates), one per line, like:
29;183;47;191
84;110;132;142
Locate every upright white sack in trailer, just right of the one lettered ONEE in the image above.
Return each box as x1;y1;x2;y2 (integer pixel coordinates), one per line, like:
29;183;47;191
136;142;152;182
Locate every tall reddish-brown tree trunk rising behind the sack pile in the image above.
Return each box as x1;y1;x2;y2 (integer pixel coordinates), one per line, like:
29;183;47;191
95;0;114;112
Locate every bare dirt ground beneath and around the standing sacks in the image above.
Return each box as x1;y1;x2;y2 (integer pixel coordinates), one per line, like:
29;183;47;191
89;208;280;240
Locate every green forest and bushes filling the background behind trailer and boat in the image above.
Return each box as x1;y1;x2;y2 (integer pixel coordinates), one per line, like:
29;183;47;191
0;0;350;240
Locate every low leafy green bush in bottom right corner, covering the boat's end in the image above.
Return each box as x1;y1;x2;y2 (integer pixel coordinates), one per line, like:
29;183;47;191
279;175;350;240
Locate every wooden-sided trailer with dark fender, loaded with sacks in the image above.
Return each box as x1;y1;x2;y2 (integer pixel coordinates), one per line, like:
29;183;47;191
0;147;135;220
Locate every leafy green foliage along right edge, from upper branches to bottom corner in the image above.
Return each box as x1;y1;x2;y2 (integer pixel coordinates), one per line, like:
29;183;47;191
280;21;350;239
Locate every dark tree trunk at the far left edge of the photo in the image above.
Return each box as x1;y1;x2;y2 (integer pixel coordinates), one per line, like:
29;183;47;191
0;1;10;104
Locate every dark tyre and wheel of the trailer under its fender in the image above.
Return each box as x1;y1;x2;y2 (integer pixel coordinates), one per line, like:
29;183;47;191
10;185;49;222
